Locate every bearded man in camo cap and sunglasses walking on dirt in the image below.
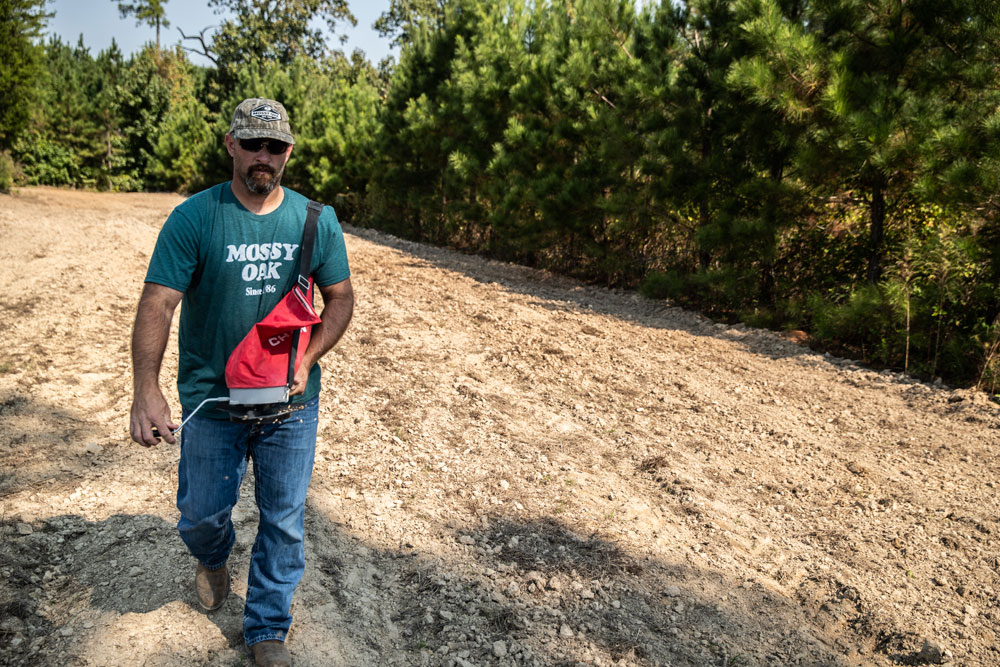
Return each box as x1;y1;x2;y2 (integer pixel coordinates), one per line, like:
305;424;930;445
130;98;354;665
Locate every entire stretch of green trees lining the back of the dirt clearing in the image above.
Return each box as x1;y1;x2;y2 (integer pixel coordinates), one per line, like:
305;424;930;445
19;0;1000;391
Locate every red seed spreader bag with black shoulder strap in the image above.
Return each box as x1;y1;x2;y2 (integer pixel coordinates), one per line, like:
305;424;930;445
226;201;323;406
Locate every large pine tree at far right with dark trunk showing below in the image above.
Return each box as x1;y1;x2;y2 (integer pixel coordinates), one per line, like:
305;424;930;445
740;0;995;284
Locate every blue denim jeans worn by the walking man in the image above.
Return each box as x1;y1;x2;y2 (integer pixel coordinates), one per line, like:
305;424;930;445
177;398;319;646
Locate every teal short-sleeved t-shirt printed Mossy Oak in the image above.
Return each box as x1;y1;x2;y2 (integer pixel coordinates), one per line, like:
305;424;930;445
146;183;351;419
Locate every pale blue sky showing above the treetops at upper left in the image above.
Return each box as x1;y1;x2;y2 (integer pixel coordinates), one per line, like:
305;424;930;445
46;0;399;65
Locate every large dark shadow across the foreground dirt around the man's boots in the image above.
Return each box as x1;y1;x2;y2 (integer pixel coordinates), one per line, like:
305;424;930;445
0;486;920;667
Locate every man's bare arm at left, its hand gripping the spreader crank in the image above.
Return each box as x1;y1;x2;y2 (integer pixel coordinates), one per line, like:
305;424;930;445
129;283;184;447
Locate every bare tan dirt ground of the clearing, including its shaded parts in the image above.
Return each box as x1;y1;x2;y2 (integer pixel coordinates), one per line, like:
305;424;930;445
0;188;1000;666
